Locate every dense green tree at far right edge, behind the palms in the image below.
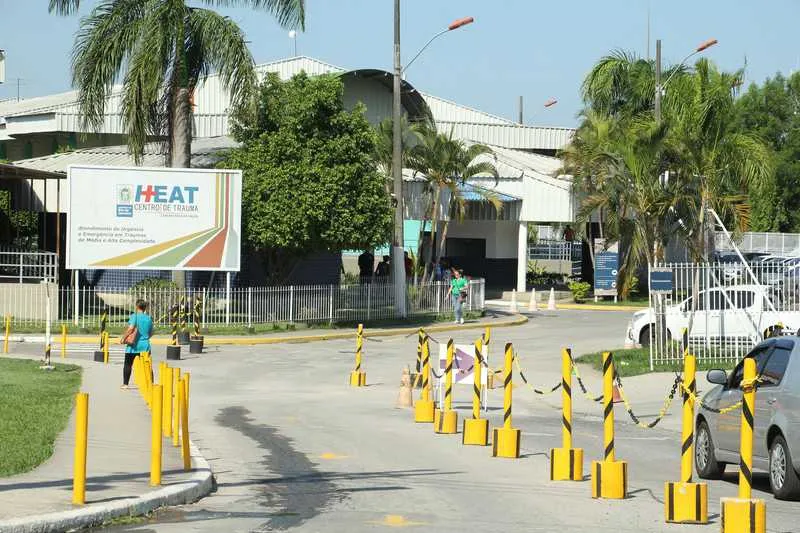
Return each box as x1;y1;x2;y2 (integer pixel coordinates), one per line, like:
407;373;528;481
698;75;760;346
736;73;800;232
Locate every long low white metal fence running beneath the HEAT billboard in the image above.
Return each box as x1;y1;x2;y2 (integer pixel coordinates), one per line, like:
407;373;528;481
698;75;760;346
0;279;485;329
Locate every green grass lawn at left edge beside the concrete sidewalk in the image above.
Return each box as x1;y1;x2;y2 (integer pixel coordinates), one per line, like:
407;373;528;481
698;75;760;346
0;358;81;476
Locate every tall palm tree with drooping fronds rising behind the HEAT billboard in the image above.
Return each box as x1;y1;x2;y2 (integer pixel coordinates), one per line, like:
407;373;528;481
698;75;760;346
50;0;305;167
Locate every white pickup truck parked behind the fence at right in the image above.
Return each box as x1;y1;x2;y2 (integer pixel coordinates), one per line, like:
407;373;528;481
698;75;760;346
625;285;800;346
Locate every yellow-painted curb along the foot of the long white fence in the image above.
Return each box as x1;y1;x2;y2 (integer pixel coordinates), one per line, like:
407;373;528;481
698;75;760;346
10;315;528;348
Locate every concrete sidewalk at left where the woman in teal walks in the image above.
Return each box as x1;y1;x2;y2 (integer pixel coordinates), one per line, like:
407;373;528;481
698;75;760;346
0;352;211;532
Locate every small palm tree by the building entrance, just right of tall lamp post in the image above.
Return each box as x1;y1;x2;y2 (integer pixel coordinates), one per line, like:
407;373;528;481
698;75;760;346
409;124;502;278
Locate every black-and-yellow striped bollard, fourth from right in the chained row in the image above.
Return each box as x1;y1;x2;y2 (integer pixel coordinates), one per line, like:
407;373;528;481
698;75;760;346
550;348;583;481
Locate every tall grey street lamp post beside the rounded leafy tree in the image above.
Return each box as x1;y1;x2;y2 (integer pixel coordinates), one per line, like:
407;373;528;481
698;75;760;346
391;0;474;318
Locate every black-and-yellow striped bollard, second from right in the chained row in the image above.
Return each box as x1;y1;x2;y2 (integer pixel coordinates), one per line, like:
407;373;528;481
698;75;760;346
664;350;708;524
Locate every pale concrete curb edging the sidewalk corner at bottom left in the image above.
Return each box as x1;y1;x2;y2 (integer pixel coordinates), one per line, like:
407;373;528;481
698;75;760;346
0;441;214;533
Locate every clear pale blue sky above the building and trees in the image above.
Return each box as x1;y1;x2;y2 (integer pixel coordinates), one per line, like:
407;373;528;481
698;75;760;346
0;0;800;126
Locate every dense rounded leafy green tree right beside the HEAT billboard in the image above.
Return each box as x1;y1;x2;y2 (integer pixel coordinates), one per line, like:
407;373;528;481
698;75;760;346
221;73;392;282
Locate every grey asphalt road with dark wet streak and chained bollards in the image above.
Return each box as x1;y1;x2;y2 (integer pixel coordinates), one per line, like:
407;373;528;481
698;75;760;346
94;311;800;533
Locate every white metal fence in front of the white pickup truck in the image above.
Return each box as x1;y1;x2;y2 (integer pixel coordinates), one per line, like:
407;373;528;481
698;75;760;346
648;260;800;365
